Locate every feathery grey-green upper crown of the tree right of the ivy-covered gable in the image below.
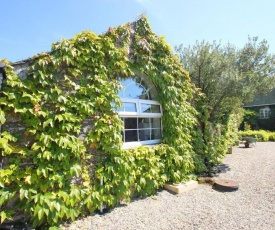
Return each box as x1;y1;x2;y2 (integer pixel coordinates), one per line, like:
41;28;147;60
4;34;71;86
176;37;275;123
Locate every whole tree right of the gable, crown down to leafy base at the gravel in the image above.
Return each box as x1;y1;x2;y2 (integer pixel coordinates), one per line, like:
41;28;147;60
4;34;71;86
175;37;275;172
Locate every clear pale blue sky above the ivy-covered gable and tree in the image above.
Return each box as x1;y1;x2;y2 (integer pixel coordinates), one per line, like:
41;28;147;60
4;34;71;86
0;0;275;62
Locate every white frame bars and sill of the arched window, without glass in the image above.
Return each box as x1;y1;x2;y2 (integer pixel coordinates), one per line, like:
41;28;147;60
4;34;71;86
118;98;162;148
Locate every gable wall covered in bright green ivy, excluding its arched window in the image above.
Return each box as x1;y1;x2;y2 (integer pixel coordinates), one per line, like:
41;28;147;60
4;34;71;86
0;17;237;226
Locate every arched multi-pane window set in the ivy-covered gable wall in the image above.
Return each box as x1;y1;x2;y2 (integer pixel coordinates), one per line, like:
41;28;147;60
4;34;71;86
118;77;162;147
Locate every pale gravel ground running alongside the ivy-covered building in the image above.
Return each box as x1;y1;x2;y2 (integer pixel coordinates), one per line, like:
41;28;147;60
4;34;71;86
63;142;275;230
